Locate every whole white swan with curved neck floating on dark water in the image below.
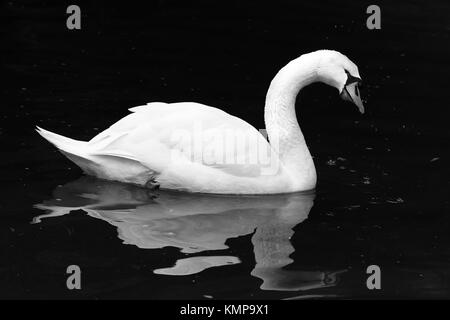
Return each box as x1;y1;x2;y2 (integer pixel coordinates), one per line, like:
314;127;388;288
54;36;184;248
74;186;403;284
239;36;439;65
37;50;364;194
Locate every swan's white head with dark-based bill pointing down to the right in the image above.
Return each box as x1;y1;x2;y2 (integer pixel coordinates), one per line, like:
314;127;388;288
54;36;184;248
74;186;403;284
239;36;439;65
315;50;364;113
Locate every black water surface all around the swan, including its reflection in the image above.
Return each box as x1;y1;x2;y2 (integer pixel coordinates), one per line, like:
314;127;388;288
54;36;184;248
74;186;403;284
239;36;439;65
0;1;450;299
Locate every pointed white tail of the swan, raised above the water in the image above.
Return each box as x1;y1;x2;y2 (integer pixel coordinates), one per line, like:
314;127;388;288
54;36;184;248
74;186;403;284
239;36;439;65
36;127;95;174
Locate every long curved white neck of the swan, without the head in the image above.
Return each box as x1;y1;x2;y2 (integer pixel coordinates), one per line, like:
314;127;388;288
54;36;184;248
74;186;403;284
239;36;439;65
264;55;321;189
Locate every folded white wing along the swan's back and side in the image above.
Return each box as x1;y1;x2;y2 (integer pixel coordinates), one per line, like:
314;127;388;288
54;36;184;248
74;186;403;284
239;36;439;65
89;102;272;177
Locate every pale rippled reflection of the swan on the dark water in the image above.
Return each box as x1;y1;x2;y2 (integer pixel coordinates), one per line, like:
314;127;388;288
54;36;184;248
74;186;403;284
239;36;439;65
33;177;339;290
